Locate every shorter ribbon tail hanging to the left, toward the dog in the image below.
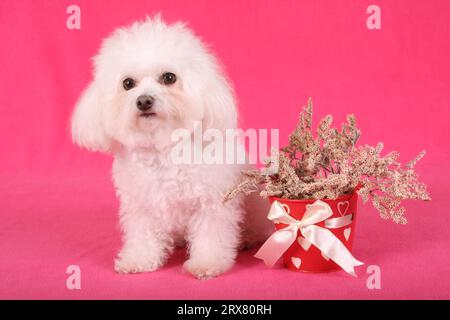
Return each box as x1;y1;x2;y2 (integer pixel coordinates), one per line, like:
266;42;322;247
254;225;298;267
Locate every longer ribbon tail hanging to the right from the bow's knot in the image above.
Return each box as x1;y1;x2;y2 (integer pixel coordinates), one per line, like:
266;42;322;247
301;225;364;277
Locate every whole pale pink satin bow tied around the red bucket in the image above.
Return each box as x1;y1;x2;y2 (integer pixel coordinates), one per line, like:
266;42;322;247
255;200;364;276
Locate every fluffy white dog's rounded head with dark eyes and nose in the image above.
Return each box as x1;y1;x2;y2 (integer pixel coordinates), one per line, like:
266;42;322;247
72;17;237;151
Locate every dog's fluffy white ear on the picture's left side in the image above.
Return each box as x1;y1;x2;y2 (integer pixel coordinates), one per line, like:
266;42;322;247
72;82;111;152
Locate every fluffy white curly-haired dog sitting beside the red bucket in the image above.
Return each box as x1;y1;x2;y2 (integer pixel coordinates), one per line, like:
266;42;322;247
72;17;269;278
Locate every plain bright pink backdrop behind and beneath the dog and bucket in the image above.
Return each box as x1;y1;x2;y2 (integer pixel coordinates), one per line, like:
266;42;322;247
0;0;450;299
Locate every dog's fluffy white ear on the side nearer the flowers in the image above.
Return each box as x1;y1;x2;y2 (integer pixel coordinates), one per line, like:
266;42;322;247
203;75;237;130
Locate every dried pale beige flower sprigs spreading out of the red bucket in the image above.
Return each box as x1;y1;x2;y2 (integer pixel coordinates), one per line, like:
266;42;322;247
225;99;431;224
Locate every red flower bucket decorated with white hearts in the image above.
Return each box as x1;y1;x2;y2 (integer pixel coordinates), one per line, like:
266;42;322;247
269;191;358;272
